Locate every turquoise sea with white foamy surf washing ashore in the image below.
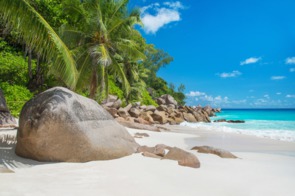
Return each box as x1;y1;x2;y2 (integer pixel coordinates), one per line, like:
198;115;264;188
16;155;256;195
181;109;295;142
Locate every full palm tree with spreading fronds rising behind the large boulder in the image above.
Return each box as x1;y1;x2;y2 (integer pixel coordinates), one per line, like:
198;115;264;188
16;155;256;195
61;0;145;98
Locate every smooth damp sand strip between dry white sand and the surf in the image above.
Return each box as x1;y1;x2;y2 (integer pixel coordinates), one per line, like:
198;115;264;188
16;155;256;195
165;125;295;157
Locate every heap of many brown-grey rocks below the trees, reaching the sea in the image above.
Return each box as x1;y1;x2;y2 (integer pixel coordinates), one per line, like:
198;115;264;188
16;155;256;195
102;95;220;126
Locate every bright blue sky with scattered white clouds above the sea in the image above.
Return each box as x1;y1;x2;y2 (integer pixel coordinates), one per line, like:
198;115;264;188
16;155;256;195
129;0;295;108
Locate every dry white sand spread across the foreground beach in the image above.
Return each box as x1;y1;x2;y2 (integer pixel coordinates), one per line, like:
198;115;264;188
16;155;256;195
0;128;295;196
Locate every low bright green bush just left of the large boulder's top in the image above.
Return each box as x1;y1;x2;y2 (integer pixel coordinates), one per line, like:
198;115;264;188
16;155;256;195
0;82;33;117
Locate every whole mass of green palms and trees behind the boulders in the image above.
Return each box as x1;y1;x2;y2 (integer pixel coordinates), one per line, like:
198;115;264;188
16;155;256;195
0;0;185;115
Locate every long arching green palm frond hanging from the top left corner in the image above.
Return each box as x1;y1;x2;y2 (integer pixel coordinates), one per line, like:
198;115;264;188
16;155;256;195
0;0;78;89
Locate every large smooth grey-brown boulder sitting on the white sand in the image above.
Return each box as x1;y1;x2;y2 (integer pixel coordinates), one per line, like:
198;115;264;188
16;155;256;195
16;87;139;162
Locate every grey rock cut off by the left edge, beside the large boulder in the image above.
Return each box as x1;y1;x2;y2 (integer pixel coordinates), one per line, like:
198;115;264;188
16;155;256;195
0;89;17;127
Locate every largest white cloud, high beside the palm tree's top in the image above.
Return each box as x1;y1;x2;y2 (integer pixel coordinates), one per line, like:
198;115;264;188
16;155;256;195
141;1;184;34
